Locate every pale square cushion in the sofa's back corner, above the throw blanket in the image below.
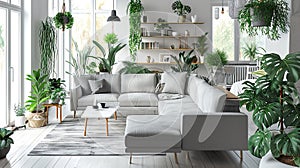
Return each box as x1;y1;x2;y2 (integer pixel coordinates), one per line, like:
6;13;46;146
161;72;187;94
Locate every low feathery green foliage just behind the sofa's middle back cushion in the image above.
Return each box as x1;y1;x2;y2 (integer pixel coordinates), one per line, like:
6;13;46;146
119;61;152;74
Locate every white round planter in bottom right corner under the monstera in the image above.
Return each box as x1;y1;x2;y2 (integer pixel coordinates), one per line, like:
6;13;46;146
259;152;295;168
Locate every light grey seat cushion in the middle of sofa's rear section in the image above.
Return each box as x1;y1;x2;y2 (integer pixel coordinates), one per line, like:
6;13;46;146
118;93;158;107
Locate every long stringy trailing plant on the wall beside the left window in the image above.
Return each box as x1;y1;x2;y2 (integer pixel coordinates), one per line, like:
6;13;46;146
39;17;57;75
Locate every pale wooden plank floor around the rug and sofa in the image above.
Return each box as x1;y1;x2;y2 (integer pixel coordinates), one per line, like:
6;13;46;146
0;105;259;168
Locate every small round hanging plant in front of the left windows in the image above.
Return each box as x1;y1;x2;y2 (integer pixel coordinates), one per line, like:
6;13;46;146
53;3;74;31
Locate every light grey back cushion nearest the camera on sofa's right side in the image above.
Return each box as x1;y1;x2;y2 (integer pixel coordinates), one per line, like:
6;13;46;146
195;78;226;113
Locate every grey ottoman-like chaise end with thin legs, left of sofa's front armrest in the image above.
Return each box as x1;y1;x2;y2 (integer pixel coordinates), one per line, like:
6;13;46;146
125;115;181;163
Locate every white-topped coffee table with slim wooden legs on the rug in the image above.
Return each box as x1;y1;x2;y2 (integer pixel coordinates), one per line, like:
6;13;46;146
81;106;118;136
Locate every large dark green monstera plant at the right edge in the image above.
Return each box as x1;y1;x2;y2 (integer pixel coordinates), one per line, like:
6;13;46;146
239;52;300;166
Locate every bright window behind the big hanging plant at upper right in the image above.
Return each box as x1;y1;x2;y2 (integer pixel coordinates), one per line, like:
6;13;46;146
212;6;266;63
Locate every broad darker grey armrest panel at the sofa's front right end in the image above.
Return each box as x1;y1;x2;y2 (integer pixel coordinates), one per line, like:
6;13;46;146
181;112;248;150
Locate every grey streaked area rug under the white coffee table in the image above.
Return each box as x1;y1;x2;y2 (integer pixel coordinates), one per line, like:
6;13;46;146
28;116;143;156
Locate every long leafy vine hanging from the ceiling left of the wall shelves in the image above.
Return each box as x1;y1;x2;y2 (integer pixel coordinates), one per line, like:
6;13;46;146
127;0;144;61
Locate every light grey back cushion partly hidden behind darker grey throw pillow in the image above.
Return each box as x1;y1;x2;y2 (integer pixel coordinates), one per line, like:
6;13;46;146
96;74;121;93
